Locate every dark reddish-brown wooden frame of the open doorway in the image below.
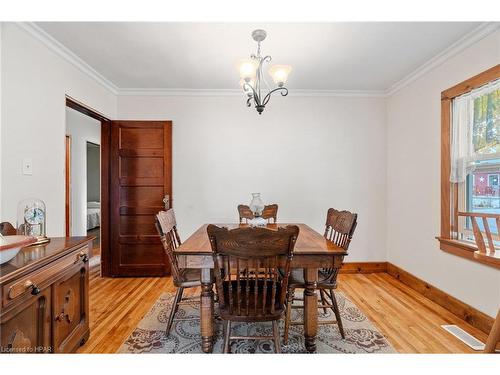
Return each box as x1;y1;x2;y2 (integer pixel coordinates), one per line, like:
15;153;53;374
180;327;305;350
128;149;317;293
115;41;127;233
65;95;111;277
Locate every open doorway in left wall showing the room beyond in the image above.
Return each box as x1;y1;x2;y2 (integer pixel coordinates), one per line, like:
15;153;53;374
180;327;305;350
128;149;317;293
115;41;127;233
65;97;110;276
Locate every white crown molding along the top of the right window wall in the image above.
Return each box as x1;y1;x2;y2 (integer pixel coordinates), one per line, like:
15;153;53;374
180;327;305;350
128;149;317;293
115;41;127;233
386;22;500;97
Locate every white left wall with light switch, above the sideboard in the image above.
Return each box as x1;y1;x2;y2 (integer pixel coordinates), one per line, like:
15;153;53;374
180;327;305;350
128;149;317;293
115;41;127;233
0;23;116;236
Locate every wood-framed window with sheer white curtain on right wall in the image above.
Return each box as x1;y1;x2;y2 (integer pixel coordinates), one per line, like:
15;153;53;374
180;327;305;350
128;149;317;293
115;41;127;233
439;65;500;268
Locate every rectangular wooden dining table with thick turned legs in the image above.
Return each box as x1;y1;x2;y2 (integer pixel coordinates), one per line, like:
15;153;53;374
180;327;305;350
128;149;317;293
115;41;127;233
175;223;347;353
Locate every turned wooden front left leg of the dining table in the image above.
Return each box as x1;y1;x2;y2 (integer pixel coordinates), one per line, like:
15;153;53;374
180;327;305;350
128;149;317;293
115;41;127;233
200;268;214;353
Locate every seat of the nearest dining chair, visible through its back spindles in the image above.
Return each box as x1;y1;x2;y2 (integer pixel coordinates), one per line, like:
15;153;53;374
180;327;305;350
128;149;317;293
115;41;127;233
220;280;285;322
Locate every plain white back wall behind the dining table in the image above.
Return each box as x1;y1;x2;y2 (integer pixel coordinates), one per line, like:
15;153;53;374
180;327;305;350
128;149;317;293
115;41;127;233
118;96;386;261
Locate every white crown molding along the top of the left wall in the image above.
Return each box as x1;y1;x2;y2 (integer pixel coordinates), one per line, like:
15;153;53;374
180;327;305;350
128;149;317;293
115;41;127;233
17;22;118;95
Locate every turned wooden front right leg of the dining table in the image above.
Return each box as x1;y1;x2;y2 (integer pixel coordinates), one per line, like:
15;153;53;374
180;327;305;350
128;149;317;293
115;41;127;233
304;268;318;353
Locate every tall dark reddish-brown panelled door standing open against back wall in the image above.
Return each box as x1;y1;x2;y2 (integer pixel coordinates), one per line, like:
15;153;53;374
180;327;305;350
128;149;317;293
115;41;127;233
110;121;172;276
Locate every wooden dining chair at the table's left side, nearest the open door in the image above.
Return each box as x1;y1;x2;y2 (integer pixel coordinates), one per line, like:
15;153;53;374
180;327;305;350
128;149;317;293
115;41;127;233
155;209;201;335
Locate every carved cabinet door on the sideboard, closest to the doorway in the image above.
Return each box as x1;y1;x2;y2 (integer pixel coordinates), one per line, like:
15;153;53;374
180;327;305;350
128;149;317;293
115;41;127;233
52;257;90;353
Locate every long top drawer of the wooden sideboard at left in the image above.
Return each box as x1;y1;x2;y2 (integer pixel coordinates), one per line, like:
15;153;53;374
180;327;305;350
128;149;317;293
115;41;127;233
2;245;89;307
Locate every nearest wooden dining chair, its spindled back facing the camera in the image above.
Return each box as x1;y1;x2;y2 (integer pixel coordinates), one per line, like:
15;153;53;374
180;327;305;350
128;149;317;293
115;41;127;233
207;225;299;353
